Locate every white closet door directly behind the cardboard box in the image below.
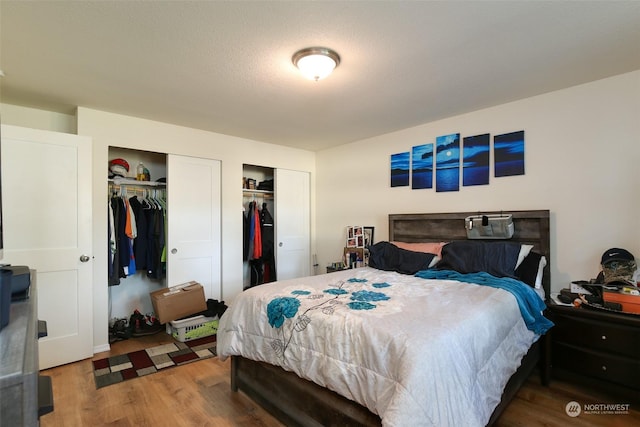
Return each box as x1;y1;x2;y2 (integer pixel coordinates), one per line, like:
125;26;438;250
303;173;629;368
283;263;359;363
167;154;222;300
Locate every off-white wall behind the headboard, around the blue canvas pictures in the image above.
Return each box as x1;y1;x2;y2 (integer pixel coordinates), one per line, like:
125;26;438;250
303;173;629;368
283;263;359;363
316;71;640;290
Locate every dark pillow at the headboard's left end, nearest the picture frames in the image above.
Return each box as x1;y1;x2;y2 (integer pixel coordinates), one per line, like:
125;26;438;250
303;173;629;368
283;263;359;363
369;242;436;274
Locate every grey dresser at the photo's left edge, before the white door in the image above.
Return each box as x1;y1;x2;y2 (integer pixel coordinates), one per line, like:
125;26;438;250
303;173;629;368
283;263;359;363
0;274;53;427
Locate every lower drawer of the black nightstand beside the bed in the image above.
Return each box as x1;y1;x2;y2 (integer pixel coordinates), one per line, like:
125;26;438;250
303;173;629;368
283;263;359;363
552;342;640;390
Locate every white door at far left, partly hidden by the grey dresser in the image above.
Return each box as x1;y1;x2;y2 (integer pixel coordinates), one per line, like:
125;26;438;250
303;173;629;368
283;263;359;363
1;125;93;369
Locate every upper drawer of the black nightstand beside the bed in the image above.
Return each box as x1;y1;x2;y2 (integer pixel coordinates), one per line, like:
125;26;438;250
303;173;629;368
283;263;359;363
552;315;640;358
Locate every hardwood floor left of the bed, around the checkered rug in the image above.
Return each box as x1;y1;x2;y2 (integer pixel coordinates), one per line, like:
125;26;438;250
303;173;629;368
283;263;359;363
40;332;282;427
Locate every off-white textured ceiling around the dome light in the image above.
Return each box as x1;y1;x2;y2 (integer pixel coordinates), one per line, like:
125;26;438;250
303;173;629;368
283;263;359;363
0;0;640;150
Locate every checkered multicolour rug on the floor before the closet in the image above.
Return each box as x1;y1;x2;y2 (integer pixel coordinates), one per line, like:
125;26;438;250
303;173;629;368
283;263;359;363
93;335;216;388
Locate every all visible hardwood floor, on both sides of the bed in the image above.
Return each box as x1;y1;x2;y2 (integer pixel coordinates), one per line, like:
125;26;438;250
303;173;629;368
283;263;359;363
40;333;640;427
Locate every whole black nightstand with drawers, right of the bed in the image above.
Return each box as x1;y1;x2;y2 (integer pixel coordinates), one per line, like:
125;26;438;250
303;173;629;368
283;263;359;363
548;303;640;402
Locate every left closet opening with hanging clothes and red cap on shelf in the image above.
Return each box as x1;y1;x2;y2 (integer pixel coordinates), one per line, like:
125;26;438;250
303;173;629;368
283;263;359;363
106;147;167;332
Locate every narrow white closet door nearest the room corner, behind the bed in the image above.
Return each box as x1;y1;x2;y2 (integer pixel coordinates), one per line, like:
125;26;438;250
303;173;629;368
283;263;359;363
275;169;311;280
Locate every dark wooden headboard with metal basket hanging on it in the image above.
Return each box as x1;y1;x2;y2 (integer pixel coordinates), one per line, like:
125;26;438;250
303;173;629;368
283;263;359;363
389;210;551;299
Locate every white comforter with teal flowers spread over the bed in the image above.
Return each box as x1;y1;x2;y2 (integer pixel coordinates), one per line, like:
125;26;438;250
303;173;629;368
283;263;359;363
218;267;538;427
